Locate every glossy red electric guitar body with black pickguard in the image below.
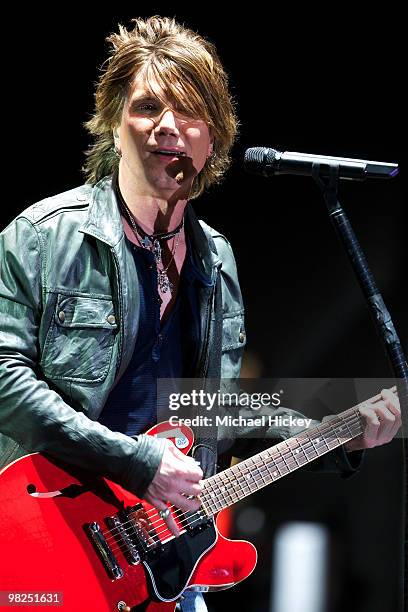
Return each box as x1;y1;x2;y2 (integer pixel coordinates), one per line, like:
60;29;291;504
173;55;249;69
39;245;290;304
0;424;257;612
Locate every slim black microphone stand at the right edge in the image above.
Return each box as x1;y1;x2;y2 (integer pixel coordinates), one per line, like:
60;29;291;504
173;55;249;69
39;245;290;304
312;163;408;611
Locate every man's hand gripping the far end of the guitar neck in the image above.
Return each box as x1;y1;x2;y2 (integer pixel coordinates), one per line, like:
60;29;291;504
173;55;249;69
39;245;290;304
344;389;401;452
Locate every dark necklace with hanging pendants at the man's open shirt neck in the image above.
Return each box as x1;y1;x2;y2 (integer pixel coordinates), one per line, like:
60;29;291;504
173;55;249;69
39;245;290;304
115;178;184;293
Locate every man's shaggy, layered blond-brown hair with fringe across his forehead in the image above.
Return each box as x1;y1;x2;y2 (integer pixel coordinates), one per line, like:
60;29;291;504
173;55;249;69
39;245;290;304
83;16;238;199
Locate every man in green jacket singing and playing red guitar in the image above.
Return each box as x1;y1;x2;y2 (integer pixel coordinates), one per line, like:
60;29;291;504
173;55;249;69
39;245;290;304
0;17;400;610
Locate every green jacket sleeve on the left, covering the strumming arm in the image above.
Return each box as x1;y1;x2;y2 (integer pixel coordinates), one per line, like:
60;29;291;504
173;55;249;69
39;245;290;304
0;217;164;497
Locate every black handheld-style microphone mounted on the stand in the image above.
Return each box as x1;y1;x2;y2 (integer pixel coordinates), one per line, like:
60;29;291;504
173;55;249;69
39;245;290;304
244;147;399;181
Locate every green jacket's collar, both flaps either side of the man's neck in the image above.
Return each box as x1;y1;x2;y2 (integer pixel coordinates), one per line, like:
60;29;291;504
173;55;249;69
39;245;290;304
79;176;221;274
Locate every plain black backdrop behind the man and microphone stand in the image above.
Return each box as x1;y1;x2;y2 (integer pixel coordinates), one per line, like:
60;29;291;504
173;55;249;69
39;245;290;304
1;2;408;612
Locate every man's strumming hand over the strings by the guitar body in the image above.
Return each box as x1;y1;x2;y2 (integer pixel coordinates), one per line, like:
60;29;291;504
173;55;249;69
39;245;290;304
145;440;203;536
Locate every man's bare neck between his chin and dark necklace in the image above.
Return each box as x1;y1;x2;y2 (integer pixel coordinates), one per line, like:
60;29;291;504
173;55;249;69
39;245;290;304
118;166;188;234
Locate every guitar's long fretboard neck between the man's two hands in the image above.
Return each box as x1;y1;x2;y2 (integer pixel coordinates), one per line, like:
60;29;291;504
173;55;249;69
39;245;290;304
201;396;364;516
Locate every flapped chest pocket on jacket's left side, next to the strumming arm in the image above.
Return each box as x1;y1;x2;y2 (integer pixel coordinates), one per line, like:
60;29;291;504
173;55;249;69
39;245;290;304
40;294;118;382
